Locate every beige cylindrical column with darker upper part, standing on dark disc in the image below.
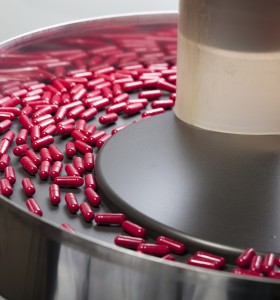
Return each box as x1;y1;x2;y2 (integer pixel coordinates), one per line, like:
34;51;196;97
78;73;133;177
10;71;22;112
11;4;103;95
175;0;280;134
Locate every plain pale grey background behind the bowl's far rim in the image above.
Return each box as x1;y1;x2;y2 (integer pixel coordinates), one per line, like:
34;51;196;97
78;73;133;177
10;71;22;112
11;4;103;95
0;0;178;42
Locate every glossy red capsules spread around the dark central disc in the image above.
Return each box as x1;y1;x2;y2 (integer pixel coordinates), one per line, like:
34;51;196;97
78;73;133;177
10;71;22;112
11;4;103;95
0;28;280;278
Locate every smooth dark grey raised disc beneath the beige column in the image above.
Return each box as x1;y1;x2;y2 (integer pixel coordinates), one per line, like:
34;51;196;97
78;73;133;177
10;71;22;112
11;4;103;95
96;112;280;257
